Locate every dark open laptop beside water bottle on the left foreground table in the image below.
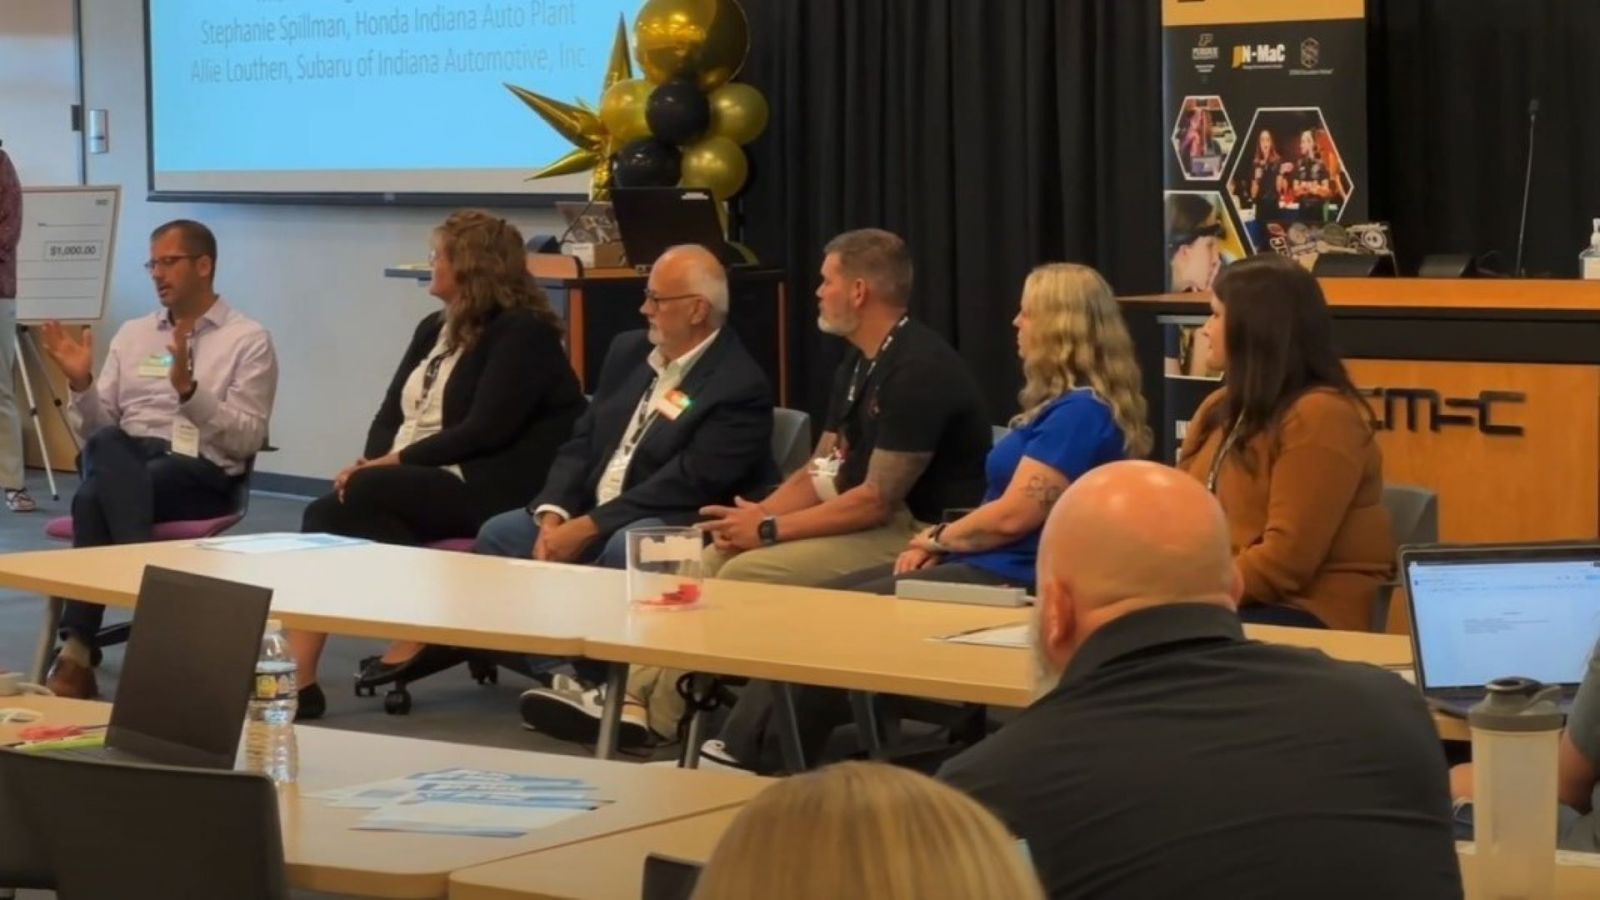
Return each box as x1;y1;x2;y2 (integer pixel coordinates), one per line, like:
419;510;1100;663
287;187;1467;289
59;565;272;769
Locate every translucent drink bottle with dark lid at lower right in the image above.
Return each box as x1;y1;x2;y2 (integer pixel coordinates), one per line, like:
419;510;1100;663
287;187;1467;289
1467;677;1562;900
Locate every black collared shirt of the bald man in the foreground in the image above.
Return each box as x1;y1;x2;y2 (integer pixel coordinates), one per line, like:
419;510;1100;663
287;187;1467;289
939;604;1461;900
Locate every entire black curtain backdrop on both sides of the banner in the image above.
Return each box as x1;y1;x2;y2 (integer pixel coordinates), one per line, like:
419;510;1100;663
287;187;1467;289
741;0;1600;421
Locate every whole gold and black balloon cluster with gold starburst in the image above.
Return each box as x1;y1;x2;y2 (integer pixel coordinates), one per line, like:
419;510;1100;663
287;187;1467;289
506;0;768;216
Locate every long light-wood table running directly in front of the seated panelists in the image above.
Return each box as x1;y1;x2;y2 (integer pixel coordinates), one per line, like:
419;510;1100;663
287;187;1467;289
0;541;1452;757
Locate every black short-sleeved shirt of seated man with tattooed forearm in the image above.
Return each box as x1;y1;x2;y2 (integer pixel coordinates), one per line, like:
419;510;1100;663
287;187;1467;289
827;320;994;522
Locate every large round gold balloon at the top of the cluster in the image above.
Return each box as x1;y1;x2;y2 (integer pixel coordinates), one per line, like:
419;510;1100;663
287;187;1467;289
634;0;750;91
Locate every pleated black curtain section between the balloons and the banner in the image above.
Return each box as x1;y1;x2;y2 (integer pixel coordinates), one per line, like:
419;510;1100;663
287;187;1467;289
741;0;1163;421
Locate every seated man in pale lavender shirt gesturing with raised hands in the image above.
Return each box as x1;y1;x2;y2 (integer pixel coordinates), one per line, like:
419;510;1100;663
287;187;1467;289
42;219;278;698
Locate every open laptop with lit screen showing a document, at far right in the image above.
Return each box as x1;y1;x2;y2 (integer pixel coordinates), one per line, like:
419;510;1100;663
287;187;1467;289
1400;543;1600;716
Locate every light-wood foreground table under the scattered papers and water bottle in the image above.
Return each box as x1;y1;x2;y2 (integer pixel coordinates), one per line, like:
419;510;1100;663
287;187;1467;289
0;697;768;897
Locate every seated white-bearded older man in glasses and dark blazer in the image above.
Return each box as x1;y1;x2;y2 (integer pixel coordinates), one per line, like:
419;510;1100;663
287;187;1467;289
477;245;778;745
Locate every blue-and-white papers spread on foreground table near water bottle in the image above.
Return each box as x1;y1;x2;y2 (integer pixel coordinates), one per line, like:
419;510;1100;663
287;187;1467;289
355;791;603;838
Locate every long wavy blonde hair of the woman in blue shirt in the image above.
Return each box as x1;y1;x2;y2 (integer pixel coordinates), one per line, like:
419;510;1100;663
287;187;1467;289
1011;263;1155;460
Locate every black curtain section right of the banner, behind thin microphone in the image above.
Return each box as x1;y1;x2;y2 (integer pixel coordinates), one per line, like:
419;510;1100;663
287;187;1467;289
1368;0;1600;279
